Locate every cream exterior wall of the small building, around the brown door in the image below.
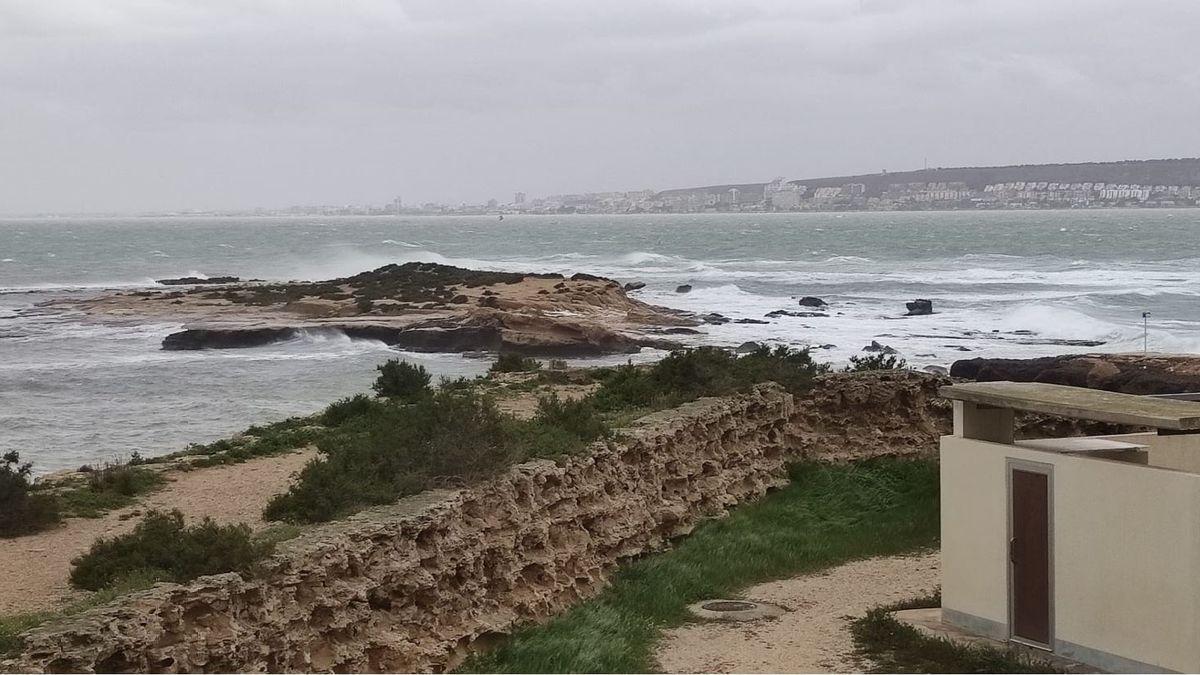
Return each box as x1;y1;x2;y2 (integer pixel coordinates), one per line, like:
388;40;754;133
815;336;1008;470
941;436;1200;671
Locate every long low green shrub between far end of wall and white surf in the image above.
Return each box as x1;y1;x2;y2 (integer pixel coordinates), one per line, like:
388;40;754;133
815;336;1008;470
595;346;829;411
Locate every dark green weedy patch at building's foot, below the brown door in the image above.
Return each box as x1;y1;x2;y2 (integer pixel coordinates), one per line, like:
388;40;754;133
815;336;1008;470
850;595;1063;673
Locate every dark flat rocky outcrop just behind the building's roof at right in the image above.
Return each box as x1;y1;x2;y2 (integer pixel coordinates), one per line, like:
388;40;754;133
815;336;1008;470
950;354;1200;394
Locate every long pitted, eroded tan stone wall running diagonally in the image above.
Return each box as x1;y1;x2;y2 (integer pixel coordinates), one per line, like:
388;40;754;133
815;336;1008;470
0;374;948;671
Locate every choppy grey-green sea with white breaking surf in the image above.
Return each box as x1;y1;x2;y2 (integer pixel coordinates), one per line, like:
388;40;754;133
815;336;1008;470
0;209;1200;473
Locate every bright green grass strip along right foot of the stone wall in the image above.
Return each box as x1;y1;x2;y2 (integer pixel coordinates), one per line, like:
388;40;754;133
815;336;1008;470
462;459;938;673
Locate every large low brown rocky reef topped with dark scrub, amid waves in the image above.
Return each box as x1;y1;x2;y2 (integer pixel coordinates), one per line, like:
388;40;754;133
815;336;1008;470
55;263;698;357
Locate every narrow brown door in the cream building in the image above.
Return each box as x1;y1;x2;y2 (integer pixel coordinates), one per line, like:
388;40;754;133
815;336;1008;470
1008;468;1050;645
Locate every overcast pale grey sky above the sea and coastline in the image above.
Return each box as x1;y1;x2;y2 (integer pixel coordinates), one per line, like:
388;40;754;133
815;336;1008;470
0;0;1200;214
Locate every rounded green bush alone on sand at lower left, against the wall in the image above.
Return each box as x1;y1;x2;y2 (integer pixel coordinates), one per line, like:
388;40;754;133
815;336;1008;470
71;510;271;591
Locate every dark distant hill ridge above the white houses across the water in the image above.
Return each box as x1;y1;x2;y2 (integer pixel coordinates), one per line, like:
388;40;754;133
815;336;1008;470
658;157;1200;199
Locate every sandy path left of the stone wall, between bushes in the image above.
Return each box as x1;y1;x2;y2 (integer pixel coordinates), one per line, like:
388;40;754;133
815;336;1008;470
0;449;316;615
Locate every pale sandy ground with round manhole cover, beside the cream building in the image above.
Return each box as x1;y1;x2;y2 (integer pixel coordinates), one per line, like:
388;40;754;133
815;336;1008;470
656;552;940;673
